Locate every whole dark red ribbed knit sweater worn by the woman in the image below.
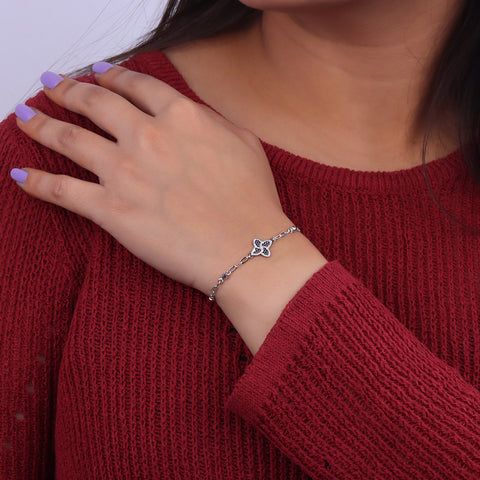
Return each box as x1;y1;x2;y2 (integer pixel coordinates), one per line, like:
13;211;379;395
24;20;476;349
0;52;480;480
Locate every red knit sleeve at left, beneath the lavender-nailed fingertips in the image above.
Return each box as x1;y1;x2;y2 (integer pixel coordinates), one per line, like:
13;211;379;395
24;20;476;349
0;92;96;480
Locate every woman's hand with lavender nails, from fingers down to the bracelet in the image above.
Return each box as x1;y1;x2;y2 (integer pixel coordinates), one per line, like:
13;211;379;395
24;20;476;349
11;63;292;295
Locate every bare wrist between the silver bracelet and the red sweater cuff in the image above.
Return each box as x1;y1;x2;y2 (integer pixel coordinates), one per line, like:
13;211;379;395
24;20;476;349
215;232;328;355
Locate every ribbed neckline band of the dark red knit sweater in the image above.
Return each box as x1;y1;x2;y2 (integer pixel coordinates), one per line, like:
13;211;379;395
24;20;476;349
139;50;467;193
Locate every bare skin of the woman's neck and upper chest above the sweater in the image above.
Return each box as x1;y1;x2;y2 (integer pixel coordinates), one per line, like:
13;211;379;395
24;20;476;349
165;0;462;171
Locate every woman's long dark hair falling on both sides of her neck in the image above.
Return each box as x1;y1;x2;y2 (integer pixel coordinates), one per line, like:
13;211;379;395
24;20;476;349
76;0;480;233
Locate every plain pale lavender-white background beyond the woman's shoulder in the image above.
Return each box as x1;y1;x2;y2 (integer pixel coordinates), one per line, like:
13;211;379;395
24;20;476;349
0;0;166;120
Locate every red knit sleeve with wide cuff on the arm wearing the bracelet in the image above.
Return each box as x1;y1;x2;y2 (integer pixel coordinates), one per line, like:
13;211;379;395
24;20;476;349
227;260;480;480
